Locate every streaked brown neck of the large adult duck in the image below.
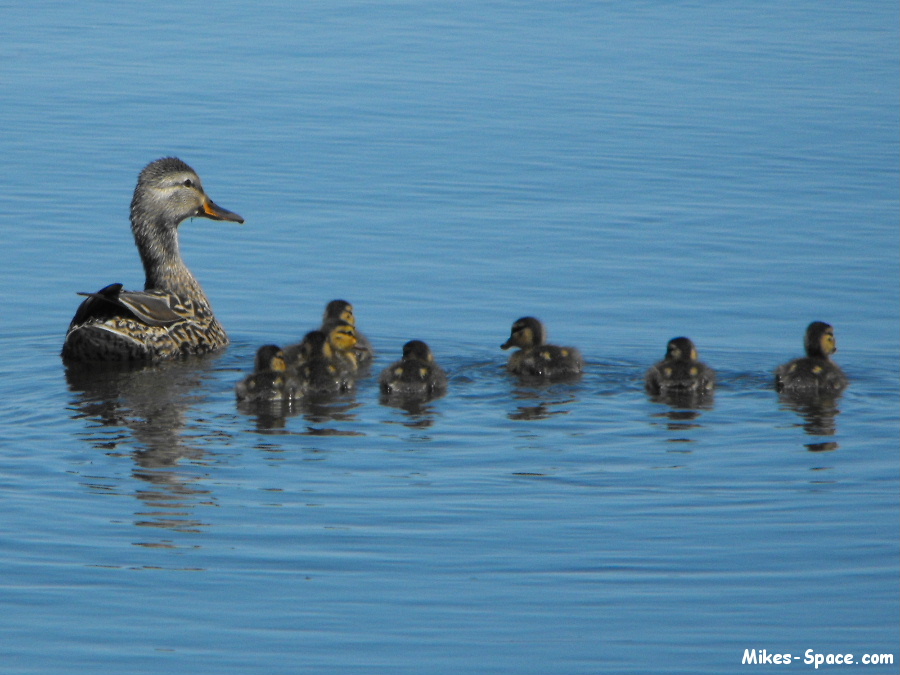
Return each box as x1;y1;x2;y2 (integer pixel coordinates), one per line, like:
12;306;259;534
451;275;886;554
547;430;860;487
131;209;209;305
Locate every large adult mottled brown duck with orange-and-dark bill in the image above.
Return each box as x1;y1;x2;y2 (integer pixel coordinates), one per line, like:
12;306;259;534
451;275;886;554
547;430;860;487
62;157;244;361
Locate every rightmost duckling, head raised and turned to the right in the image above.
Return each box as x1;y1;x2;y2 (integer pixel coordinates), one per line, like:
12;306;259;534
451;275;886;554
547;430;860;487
775;321;849;394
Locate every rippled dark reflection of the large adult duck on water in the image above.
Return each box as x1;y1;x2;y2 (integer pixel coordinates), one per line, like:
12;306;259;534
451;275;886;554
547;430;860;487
66;355;228;531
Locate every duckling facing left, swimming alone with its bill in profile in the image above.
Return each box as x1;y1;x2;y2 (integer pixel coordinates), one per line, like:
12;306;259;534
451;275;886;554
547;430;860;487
500;316;584;380
